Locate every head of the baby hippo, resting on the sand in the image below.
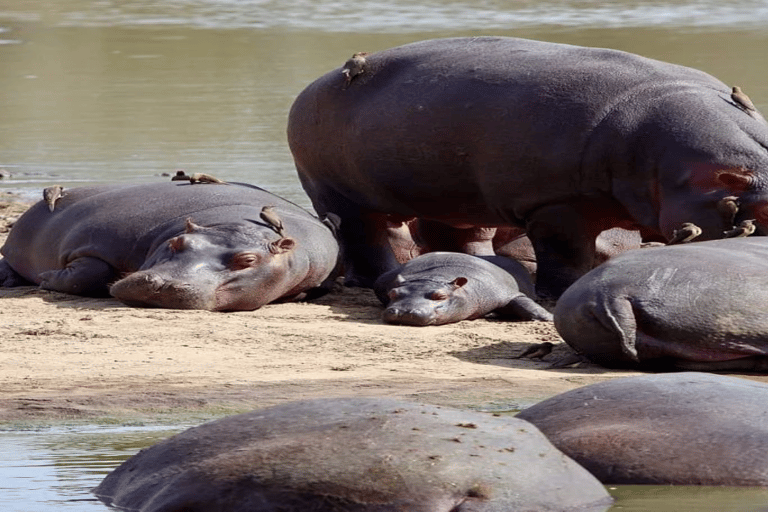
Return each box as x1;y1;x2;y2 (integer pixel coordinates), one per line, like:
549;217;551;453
382;275;474;326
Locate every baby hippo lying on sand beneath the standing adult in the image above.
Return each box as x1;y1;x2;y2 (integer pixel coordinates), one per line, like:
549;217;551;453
373;252;552;326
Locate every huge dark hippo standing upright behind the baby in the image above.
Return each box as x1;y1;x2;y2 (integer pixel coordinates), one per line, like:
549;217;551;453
288;37;768;298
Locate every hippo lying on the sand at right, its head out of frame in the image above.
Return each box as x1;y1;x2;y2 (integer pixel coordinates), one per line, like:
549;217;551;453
554;237;768;371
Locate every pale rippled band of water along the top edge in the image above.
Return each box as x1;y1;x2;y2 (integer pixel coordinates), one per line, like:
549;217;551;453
0;0;768;33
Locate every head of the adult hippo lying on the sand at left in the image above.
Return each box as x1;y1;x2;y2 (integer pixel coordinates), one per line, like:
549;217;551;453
110;219;304;311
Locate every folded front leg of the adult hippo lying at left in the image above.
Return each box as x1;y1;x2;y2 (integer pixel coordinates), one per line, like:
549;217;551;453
38;256;117;297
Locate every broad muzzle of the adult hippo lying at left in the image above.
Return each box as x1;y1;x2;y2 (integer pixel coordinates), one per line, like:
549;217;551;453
109;272;213;310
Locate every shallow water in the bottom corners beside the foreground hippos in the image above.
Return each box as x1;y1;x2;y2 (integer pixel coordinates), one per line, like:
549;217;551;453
0;425;768;512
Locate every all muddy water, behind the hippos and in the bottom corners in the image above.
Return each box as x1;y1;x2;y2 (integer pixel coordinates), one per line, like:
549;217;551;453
0;0;768;512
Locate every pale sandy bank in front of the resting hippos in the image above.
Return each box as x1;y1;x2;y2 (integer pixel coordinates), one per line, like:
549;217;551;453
0;201;760;428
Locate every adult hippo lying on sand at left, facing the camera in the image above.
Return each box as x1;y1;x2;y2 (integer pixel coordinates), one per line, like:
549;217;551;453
0;181;339;311
